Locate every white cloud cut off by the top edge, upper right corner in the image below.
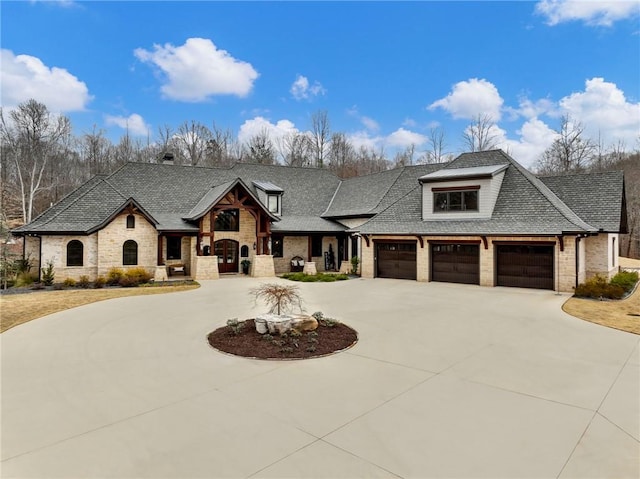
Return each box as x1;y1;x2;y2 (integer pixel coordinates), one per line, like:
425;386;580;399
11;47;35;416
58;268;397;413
536;0;640;27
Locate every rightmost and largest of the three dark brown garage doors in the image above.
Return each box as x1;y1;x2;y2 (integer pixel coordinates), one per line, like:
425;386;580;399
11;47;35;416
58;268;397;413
496;244;553;289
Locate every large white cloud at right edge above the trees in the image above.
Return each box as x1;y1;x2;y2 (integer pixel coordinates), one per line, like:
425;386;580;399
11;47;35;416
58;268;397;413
560;78;640;145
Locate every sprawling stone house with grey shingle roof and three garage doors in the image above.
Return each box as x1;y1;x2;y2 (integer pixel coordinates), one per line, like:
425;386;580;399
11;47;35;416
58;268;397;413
13;150;626;291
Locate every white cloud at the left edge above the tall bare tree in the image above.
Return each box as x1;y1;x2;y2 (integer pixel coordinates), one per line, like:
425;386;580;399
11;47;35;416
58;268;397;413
0;49;93;112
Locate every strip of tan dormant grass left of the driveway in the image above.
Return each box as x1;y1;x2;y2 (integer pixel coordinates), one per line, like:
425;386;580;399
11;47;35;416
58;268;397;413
0;283;200;333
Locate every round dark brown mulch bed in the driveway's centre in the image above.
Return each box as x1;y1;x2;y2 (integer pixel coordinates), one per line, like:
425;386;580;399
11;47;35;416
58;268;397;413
207;319;358;359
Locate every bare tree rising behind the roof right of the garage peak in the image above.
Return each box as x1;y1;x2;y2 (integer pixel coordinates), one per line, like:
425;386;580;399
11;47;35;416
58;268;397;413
536;115;597;174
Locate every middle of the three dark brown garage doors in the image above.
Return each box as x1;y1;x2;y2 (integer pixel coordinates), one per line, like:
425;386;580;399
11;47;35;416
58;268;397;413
431;243;480;284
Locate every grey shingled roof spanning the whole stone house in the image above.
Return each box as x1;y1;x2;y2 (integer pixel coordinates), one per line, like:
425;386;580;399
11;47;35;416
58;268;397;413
13;150;626;239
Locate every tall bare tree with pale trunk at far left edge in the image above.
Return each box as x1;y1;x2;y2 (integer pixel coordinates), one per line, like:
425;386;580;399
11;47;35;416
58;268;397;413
0;100;71;223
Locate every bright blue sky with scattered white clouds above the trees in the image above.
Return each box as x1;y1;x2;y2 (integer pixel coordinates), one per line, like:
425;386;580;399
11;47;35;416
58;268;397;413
0;0;640;167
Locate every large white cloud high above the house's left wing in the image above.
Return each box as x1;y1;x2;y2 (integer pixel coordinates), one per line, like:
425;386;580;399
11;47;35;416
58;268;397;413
134;38;258;102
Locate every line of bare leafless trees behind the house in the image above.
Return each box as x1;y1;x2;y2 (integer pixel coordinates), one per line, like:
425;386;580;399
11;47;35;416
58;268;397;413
0;99;640;255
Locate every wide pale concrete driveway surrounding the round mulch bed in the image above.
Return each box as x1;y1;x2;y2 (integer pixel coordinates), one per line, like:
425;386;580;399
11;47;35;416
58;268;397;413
0;277;640;479
